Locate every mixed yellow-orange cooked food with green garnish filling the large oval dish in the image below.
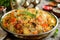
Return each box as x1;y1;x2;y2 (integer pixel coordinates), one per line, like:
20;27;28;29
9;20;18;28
1;8;57;35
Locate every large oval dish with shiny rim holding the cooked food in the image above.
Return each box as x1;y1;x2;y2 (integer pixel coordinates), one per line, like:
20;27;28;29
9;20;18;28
1;9;58;39
